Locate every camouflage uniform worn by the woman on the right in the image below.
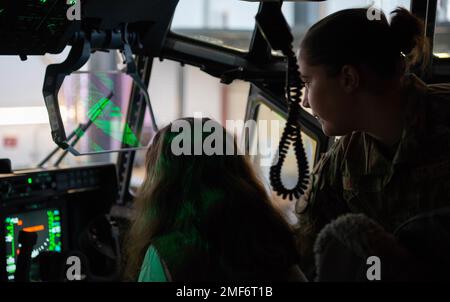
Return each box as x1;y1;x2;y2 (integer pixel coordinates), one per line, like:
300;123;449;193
296;75;450;277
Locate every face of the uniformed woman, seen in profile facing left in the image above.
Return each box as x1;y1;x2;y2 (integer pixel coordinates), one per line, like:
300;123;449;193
299;53;353;136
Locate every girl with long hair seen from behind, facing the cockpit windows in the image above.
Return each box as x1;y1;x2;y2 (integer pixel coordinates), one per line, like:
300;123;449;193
126;118;304;281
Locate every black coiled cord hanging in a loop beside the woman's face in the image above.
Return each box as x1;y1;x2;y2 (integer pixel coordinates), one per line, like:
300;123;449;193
270;47;309;200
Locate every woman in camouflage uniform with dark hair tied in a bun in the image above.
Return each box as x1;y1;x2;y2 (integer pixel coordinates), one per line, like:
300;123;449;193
296;8;450;277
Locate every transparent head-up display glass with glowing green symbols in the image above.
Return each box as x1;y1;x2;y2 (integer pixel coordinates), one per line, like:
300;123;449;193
61;71;149;154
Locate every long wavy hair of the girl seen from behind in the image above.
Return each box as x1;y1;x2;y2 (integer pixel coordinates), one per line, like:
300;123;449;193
125;118;298;281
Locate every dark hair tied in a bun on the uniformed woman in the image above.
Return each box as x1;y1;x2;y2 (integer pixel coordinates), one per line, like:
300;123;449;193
300;7;429;78
